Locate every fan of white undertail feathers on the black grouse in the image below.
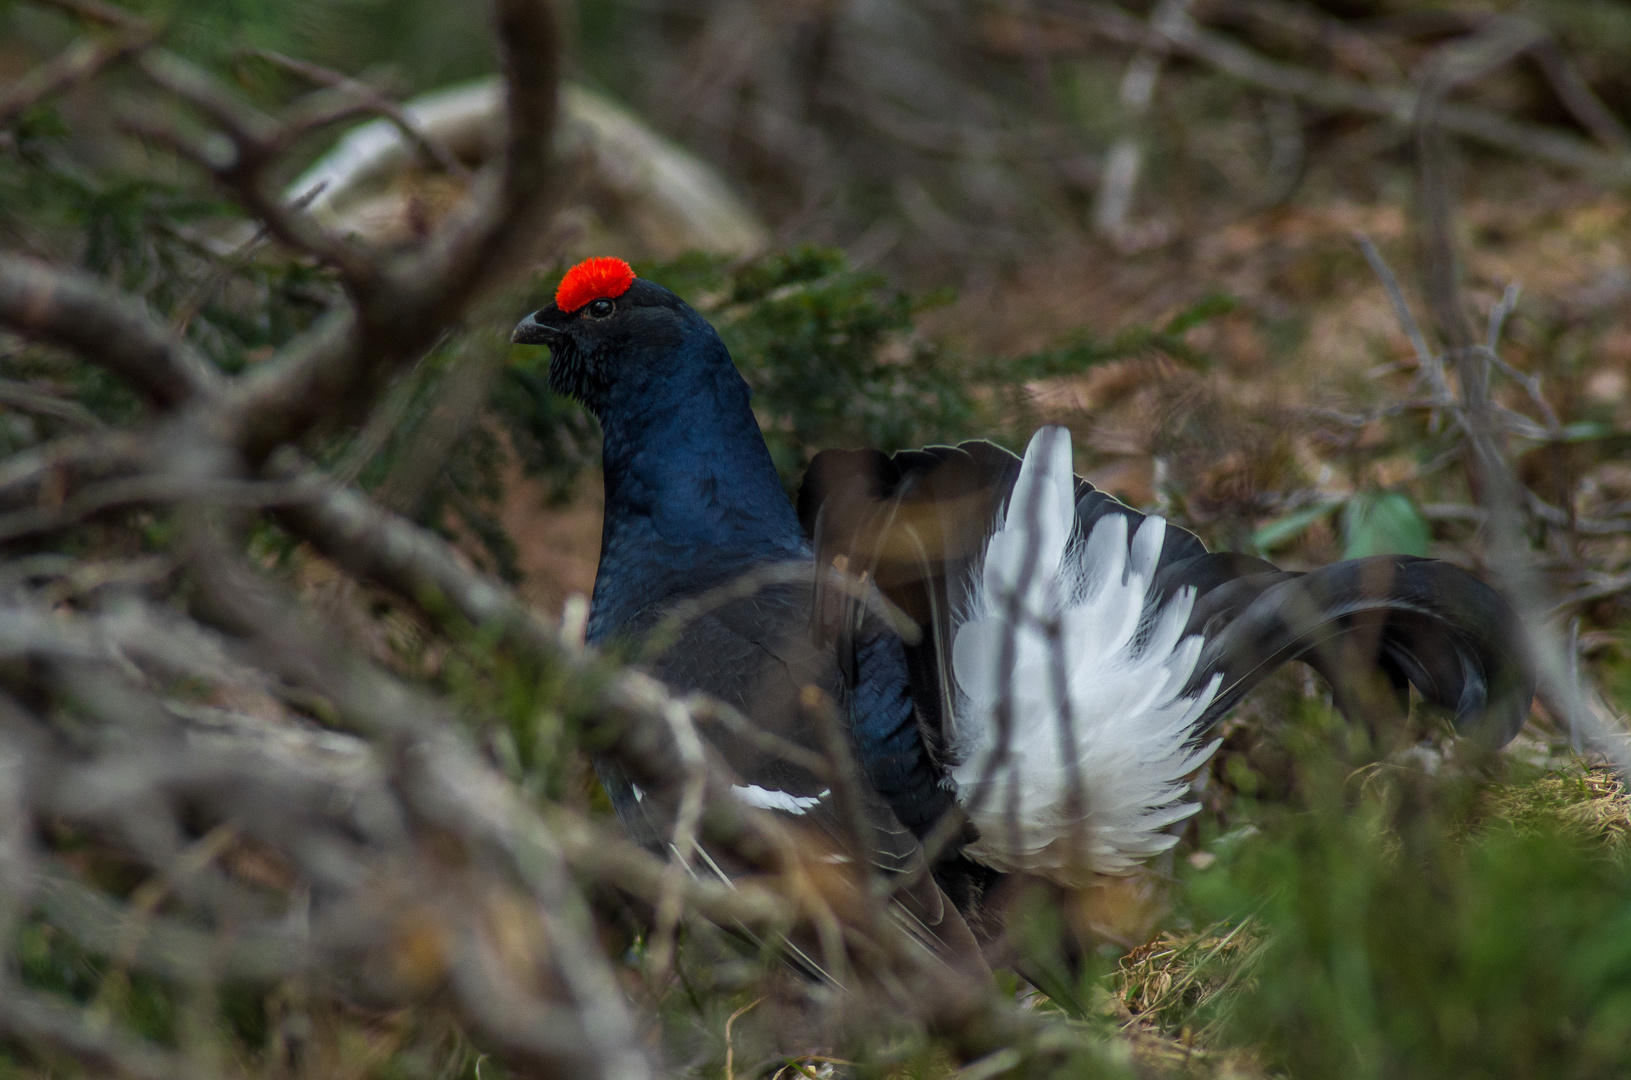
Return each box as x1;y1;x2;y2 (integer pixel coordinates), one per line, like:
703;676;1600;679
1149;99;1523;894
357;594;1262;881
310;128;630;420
951;427;1218;883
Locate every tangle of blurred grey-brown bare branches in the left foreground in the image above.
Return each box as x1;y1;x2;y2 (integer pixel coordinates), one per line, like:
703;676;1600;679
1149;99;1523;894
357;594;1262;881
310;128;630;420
0;0;1109;1080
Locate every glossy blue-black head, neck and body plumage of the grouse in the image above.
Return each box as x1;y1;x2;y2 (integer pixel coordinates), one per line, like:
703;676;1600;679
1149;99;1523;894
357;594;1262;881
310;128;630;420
515;281;951;866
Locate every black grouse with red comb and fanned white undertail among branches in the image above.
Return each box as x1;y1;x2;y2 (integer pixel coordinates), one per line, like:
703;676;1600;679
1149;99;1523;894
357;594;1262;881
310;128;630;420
514;258;1533;951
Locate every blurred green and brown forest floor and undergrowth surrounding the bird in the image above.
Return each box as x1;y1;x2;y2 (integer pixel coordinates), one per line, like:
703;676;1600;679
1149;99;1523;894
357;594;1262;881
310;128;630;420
0;0;1631;1080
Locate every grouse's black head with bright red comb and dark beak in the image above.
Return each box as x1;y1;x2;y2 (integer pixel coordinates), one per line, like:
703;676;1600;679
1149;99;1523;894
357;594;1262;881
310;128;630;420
511;258;731;419
